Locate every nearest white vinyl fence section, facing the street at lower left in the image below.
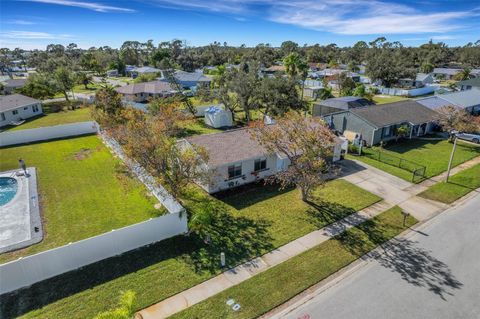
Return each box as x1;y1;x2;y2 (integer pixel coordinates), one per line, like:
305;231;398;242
0;212;187;294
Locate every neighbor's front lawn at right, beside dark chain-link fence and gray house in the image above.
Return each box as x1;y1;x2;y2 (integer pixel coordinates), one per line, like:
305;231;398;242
353;140;480;181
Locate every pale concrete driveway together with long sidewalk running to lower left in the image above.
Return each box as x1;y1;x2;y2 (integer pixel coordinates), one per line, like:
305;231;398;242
138;161;454;319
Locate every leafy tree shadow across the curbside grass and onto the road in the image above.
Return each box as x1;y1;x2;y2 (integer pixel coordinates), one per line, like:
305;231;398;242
336;220;463;300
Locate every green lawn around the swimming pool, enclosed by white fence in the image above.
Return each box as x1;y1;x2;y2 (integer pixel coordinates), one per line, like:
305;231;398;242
0;136;164;262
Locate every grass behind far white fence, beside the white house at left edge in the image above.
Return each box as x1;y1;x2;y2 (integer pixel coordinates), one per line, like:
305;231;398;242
6;107;92;131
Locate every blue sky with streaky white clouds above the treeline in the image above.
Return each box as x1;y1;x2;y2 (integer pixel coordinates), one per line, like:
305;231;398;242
0;0;480;49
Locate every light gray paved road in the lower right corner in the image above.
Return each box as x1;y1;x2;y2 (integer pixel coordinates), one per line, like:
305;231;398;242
283;195;480;319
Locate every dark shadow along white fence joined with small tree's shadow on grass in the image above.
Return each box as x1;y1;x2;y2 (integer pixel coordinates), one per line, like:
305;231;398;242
0;212;273;318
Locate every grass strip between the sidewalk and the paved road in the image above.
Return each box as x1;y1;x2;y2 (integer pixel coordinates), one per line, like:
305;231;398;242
171;207;416;319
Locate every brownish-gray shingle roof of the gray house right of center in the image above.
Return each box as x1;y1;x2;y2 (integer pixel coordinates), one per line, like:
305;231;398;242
350;100;437;128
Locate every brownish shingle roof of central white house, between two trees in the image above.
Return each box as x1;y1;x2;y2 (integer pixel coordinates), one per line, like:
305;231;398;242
187;129;266;167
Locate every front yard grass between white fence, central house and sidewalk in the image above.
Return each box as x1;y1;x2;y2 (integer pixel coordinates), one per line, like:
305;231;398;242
0;180;380;319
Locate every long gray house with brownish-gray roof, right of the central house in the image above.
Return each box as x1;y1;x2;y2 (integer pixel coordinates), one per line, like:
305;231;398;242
323;100;437;146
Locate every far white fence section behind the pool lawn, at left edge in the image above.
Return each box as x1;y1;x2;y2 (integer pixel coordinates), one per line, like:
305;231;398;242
0;121;99;147
